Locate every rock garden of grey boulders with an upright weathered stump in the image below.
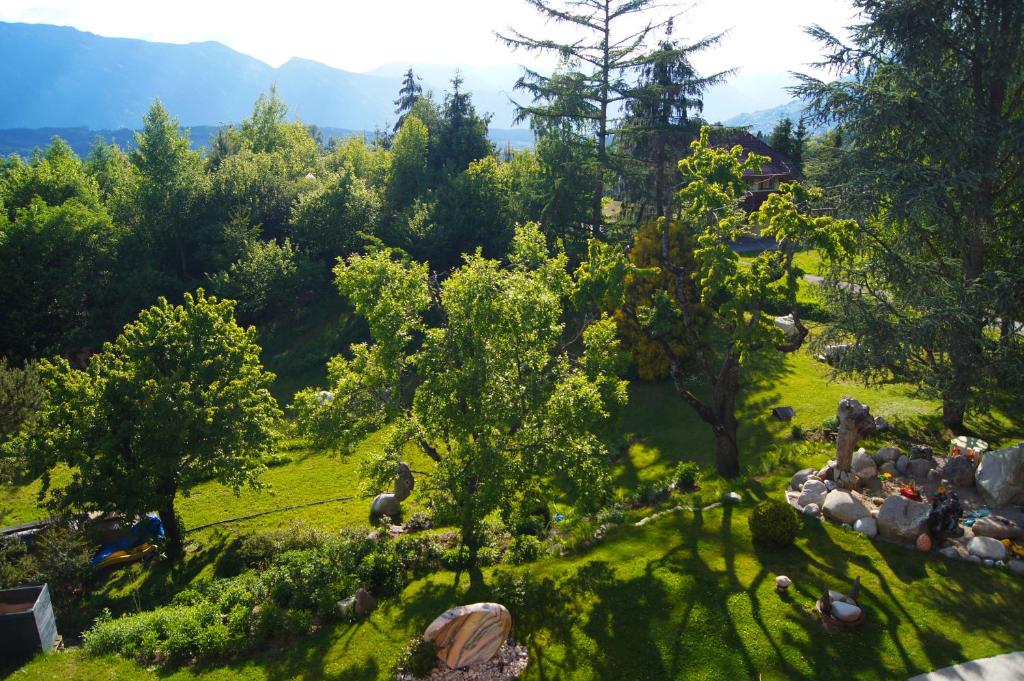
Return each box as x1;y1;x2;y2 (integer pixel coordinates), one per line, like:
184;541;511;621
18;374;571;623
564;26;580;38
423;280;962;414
785;397;1024;576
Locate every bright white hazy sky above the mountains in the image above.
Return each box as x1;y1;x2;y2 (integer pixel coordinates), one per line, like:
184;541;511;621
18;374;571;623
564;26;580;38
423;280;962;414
0;0;853;75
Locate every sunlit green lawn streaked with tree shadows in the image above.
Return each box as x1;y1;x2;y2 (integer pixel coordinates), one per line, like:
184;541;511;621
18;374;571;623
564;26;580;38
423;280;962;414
0;319;1024;681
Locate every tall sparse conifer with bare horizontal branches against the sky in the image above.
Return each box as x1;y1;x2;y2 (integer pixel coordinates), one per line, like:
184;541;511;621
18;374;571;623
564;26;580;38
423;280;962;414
497;0;675;229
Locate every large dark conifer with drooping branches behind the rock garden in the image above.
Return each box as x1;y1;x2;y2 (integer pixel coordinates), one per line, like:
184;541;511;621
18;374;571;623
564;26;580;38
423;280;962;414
796;0;1024;431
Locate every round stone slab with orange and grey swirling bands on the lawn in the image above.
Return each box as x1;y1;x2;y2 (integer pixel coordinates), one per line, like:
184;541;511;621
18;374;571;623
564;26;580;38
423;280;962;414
423;603;512;669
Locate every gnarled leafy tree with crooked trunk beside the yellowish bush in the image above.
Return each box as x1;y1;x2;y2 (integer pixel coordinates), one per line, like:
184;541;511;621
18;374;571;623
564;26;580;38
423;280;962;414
610;126;853;477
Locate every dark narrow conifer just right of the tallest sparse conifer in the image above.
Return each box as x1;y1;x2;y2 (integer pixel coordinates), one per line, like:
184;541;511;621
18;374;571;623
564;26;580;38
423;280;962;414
617;20;731;217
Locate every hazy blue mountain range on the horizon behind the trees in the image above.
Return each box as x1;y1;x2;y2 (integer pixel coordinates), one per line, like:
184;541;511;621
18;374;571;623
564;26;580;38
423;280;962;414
0;22;811;147
